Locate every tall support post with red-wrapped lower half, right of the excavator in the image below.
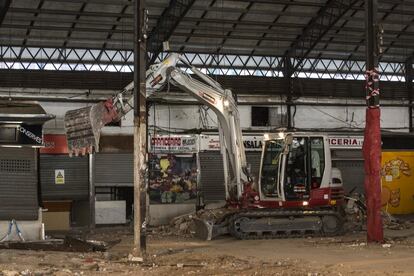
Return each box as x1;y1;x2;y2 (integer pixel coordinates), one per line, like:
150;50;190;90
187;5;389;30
363;0;384;243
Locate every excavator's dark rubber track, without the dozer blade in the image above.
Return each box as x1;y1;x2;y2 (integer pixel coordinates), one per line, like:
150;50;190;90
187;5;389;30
228;210;344;240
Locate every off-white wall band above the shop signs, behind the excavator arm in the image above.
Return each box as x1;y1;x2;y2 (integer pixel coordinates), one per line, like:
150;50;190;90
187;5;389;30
41;99;409;134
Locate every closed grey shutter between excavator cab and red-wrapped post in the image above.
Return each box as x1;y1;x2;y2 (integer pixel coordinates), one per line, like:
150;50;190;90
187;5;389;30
332;160;364;193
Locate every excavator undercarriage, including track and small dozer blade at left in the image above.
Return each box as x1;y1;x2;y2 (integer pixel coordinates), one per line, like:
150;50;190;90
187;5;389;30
194;209;344;240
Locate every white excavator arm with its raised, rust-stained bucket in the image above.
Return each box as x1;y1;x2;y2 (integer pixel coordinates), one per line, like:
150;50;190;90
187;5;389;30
65;53;251;199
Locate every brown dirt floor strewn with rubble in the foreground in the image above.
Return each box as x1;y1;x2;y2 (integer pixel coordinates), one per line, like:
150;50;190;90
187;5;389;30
0;225;414;276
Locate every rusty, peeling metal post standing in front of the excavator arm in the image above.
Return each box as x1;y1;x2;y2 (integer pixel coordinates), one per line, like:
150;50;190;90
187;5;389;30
133;0;147;258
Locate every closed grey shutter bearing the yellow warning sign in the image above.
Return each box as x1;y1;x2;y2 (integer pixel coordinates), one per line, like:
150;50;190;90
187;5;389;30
40;154;89;200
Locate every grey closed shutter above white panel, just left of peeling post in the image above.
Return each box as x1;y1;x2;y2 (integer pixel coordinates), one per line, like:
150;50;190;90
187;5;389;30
94;153;134;187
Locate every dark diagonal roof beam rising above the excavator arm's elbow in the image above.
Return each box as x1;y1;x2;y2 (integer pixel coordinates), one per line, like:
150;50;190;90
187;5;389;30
147;0;195;64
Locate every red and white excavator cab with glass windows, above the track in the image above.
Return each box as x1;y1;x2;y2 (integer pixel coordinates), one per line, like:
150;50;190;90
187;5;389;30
258;132;342;207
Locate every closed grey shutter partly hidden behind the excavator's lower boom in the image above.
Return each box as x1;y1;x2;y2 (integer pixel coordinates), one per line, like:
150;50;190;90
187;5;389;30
200;151;261;201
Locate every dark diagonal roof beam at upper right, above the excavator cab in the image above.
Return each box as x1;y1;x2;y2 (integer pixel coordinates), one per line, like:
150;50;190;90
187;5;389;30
284;0;359;75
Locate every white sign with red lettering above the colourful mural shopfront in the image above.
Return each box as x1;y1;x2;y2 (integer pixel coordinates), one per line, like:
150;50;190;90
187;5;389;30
150;135;198;153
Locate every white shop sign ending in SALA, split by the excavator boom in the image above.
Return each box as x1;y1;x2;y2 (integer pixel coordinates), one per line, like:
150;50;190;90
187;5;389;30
200;135;263;151
